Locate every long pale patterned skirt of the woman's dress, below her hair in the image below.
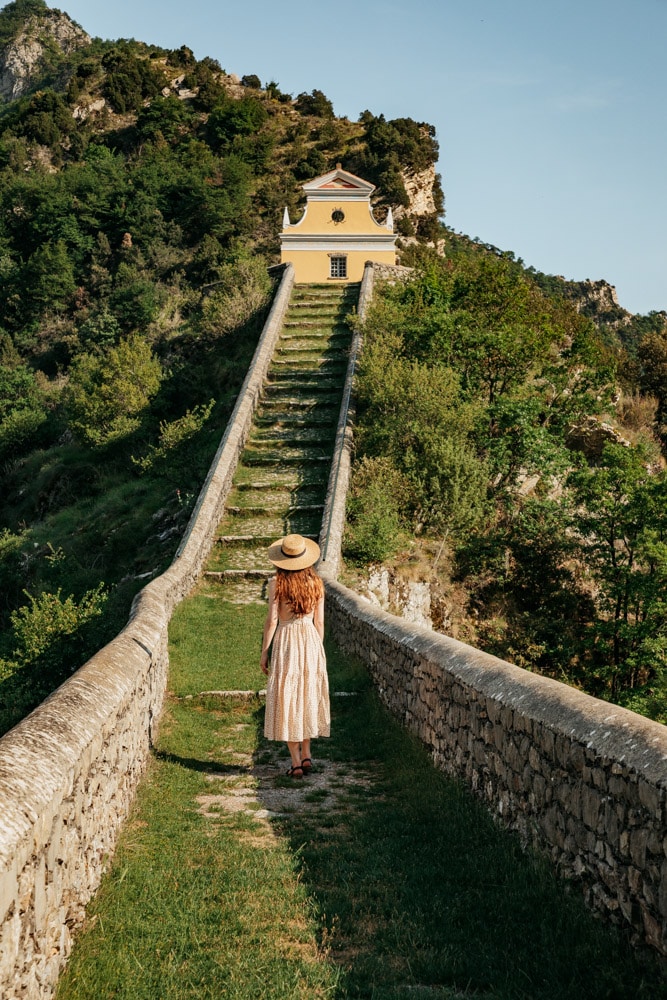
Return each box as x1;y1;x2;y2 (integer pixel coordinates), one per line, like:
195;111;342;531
264;611;330;743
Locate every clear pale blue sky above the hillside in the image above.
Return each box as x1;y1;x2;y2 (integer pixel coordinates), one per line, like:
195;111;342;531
54;0;667;313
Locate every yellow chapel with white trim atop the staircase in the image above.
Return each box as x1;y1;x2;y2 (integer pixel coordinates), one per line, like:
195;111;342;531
280;163;396;284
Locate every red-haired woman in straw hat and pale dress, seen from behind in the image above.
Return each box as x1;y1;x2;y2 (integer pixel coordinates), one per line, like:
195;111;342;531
260;535;330;778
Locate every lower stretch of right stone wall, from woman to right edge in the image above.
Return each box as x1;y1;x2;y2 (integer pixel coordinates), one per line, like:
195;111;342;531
323;584;667;956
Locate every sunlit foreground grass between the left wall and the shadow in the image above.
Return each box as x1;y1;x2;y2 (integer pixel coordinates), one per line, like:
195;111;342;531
58;706;338;1000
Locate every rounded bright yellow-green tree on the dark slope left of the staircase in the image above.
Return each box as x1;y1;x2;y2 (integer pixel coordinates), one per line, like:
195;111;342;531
65;335;163;447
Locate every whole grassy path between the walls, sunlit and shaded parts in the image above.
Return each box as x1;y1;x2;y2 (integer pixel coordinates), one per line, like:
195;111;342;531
53;594;667;1000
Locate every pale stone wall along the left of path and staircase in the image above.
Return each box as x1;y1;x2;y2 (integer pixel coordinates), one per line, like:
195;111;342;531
0;266;294;1000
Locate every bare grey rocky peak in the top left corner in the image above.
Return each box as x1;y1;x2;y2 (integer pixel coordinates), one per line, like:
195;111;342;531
0;9;91;101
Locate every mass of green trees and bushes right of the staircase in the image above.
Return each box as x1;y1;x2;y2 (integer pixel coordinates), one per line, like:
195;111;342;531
349;250;667;714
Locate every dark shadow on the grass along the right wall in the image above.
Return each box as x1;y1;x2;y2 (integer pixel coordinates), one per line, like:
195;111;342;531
250;648;667;1000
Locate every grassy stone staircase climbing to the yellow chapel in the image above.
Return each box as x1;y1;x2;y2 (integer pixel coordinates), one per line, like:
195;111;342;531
205;285;359;604
